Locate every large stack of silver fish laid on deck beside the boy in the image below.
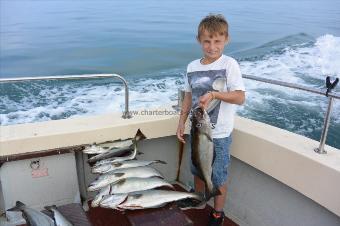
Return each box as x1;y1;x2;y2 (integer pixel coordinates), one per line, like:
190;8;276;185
83;130;202;210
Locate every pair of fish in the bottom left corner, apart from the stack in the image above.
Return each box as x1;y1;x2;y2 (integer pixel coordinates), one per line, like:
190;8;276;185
7;201;73;226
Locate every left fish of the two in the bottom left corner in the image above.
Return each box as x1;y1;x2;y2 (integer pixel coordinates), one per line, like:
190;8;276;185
7;201;55;226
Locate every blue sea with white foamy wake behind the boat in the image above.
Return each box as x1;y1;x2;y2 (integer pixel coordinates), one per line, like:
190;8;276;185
0;0;340;148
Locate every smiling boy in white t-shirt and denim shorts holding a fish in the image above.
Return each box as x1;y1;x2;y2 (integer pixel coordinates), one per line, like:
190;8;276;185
177;14;245;225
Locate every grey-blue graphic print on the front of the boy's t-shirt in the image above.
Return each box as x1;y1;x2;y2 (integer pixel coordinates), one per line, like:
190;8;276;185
187;69;226;125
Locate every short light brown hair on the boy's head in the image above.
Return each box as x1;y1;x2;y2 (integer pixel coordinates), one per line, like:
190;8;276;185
197;14;229;39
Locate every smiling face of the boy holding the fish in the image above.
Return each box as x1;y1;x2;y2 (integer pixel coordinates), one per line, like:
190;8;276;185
198;31;228;62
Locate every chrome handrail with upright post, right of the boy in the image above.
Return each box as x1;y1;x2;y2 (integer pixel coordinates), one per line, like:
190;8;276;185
242;75;340;154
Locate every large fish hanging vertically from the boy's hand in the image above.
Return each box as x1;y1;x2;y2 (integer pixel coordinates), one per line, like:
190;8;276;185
191;107;221;200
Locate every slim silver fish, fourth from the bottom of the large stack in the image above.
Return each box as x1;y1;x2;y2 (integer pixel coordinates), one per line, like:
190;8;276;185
91;160;166;174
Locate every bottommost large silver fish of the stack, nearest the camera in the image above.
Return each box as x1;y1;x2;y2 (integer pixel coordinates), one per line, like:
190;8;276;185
115;190;202;210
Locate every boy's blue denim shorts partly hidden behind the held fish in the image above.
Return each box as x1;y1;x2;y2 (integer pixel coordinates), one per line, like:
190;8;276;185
190;135;231;187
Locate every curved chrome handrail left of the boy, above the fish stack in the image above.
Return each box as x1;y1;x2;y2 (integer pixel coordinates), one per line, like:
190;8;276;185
0;74;132;119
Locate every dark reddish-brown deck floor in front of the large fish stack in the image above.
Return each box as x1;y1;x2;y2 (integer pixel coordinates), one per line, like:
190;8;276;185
20;185;237;226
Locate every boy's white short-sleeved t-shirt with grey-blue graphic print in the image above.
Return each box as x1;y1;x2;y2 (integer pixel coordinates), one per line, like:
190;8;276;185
184;55;245;138
